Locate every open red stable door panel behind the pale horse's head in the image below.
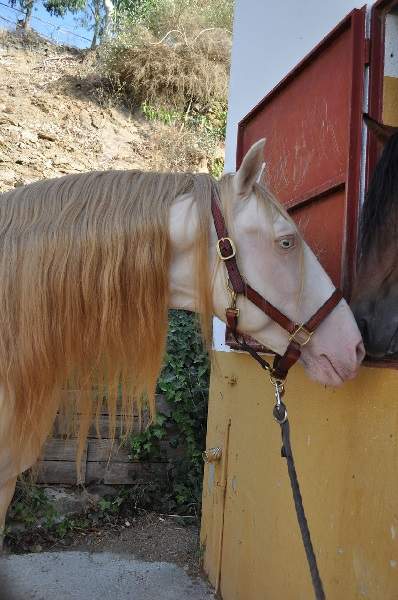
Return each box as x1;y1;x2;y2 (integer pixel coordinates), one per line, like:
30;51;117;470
237;8;366;296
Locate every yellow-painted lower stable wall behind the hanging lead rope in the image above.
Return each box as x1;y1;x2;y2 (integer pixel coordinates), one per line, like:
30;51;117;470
202;352;398;600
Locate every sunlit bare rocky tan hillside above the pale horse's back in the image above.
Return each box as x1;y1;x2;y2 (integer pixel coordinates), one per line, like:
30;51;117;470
0;31;218;192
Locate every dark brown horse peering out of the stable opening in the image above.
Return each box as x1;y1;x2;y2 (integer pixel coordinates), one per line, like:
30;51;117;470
351;116;398;358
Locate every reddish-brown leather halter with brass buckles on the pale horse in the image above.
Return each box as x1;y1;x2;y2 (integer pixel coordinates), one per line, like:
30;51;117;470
211;185;343;383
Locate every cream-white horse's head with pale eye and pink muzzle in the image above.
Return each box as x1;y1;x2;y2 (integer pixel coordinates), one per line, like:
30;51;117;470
210;140;364;385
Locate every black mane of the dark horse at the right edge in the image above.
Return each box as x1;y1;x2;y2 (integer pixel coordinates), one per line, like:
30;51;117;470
359;133;398;256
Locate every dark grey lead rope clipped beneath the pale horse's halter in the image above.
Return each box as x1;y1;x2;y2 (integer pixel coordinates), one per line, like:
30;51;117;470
232;331;326;600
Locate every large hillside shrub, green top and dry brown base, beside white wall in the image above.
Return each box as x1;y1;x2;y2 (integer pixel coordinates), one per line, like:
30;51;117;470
100;0;233;111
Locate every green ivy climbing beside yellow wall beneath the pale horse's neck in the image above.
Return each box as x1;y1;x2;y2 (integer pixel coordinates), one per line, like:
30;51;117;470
130;310;210;514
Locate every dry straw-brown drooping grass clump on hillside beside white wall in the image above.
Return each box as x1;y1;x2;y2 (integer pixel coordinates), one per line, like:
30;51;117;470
103;28;231;110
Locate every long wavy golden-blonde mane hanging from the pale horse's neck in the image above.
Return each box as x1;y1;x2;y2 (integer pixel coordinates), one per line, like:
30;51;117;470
0;171;218;468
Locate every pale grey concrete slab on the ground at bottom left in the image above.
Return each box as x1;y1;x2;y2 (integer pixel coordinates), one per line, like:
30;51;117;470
0;552;215;600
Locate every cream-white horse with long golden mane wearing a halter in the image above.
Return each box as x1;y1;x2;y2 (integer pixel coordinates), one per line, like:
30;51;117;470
0;141;364;544
